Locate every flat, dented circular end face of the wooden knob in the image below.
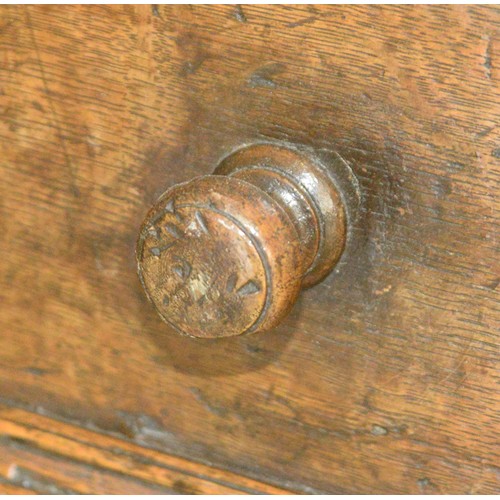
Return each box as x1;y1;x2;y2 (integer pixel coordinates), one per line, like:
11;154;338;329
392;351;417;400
139;198;267;336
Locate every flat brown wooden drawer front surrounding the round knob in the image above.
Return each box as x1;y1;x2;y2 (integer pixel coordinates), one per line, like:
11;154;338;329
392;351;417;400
0;5;500;493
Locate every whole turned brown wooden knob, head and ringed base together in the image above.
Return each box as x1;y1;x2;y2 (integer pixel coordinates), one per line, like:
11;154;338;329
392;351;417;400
137;144;346;338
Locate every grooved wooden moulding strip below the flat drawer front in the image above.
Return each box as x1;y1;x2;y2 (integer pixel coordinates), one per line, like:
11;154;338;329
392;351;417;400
0;406;290;495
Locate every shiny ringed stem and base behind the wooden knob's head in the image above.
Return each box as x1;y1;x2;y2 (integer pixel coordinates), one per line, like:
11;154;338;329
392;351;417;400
214;144;347;287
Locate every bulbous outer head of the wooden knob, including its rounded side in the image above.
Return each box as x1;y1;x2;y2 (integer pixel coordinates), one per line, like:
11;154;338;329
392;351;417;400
137;176;301;338
